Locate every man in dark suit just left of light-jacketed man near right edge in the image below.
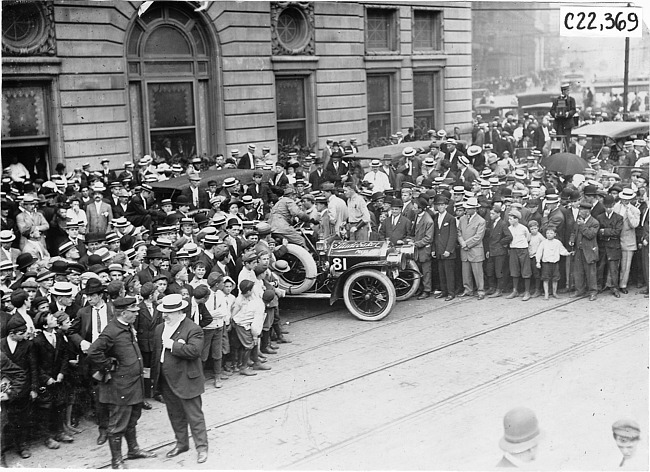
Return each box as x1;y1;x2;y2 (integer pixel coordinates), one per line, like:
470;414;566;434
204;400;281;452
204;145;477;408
596;195;623;298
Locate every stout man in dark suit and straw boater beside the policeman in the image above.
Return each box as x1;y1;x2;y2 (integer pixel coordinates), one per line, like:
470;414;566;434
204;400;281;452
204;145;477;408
151;294;208;464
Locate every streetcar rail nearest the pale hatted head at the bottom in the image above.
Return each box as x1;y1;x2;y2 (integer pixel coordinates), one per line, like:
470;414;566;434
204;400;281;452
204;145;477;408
282;317;648;469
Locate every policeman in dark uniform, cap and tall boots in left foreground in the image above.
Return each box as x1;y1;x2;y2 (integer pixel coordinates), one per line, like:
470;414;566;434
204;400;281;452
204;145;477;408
88;297;156;469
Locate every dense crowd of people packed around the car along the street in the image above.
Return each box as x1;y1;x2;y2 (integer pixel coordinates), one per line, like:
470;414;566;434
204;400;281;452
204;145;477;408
0;117;650;468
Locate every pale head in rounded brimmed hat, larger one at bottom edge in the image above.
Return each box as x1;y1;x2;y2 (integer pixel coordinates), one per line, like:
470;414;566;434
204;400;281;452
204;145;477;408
496;407;544;468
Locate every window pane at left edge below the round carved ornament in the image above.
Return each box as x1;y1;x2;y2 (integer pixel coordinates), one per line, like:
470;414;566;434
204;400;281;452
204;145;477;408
2;87;47;138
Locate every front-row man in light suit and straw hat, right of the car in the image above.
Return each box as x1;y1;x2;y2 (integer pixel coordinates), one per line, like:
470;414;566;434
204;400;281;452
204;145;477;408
458;197;485;300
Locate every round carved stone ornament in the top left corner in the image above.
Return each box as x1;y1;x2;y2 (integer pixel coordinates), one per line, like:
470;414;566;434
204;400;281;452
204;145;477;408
2;0;56;56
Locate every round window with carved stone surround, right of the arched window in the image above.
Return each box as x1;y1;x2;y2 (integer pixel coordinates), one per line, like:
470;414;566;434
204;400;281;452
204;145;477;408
271;2;315;56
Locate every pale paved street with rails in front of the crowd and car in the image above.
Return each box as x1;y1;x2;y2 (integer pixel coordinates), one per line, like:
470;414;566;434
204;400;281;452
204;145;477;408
7;292;648;470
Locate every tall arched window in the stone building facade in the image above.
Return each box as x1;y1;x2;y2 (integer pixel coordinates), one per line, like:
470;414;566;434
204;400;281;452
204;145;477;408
126;2;211;164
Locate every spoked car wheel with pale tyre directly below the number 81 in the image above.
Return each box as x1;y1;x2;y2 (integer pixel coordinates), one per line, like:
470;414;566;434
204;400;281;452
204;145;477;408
343;269;397;321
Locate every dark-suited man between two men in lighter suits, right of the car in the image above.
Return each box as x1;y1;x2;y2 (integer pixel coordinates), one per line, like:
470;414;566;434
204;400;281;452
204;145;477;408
432;195;458;302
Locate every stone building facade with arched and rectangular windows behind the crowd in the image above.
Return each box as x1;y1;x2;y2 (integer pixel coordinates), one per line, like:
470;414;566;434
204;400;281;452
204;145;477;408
2;0;472;177
